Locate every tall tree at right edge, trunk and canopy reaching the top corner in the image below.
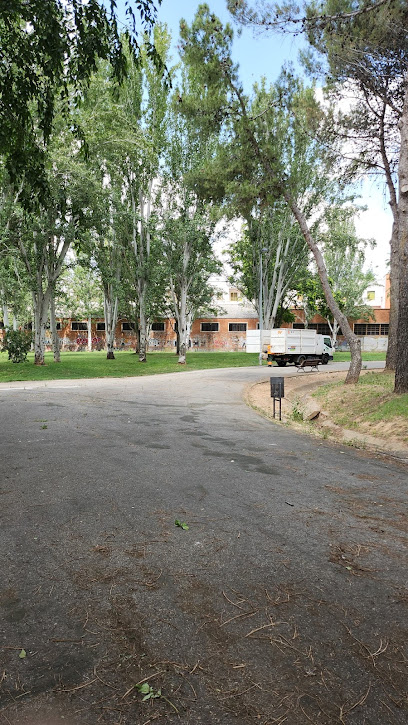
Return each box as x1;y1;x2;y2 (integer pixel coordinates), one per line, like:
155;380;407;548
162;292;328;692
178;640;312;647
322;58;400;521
228;0;408;393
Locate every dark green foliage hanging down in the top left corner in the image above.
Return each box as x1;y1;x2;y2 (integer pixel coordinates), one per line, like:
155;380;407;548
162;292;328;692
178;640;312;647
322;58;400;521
0;0;160;198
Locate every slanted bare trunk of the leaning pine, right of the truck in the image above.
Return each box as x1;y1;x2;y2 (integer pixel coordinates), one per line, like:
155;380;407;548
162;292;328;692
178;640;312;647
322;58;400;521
284;192;362;383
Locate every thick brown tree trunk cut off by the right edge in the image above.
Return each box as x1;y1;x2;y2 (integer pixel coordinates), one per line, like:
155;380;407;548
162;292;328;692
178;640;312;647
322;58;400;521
394;73;408;394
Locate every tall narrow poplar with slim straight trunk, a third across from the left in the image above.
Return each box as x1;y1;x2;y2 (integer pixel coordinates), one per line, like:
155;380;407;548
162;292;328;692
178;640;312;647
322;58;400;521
79;25;170;359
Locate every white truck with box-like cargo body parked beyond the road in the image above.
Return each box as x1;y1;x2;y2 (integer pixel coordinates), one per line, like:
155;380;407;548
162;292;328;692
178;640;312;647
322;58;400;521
246;327;333;367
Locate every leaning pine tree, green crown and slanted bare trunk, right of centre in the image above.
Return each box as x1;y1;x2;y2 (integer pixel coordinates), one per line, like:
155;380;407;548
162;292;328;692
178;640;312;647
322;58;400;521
181;5;361;383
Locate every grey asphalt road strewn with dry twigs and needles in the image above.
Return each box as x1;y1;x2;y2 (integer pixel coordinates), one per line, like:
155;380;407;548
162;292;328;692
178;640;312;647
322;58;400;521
0;363;408;725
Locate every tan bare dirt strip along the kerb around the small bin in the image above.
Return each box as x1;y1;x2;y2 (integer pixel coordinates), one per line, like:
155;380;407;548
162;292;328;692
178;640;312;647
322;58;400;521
246;370;408;460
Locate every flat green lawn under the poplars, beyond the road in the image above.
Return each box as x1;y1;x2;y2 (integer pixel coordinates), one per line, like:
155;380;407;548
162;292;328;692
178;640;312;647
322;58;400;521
0;350;385;383
